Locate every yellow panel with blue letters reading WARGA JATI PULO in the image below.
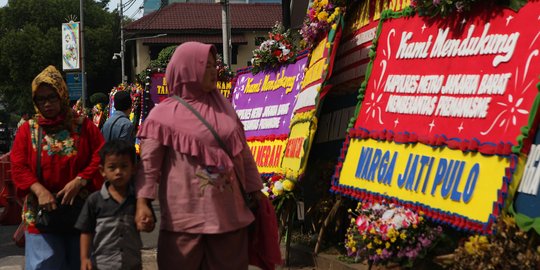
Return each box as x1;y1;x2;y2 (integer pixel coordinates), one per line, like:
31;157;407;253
339;139;511;224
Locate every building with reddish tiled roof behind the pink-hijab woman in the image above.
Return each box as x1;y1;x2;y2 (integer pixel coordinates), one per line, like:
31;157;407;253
125;3;282;78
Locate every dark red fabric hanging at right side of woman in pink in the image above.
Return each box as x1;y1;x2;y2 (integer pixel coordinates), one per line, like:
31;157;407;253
249;198;282;270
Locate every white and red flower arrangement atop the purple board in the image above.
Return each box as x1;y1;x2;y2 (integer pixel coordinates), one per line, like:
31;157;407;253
251;22;298;74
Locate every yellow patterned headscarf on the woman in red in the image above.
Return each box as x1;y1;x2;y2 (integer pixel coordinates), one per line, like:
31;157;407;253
32;66;69;113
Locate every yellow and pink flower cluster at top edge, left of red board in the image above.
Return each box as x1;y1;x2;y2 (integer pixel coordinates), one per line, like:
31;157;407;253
300;0;345;48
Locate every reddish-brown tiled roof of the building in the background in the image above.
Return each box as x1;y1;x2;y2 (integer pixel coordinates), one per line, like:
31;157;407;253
125;3;281;32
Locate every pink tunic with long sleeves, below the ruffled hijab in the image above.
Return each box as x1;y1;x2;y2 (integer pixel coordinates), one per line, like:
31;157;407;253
137;137;262;234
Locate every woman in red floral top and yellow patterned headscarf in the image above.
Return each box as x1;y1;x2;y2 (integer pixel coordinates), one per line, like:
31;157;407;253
10;66;104;269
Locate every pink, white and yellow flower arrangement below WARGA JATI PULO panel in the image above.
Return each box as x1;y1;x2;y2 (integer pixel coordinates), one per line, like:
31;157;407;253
345;202;442;267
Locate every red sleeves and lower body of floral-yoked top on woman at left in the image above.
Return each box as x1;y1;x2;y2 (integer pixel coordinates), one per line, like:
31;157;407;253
10;118;104;197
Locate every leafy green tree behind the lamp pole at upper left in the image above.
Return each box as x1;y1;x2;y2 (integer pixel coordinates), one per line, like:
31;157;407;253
0;0;120;113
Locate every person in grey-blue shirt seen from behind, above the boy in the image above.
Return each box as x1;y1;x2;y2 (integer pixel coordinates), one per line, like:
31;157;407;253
101;91;135;143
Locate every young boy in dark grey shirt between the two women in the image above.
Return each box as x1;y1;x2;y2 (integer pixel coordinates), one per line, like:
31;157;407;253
75;140;142;270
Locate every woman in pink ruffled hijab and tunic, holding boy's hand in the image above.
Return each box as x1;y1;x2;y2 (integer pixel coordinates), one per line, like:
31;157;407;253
136;42;264;270
